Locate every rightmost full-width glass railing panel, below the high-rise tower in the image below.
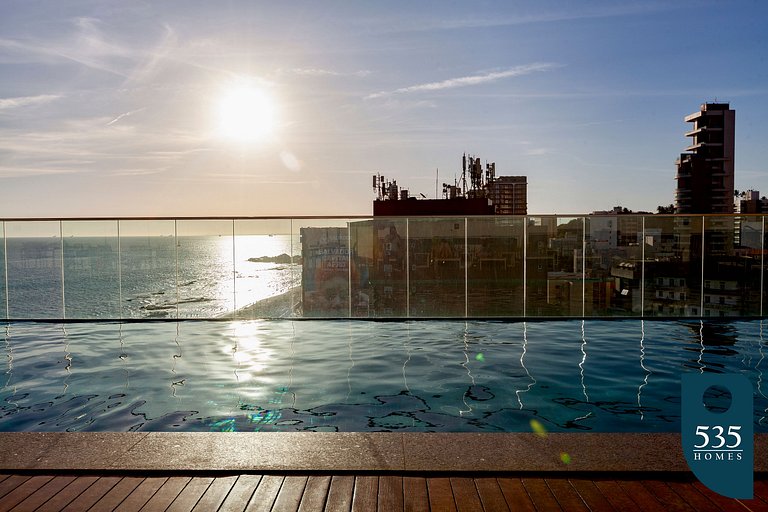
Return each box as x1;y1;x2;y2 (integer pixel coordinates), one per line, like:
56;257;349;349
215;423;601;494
703;216;763;318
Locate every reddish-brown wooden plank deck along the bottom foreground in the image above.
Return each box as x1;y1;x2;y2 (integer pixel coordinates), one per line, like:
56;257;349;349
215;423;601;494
0;472;768;512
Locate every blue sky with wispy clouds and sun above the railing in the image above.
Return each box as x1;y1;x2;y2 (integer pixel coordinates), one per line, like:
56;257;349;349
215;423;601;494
0;0;768;218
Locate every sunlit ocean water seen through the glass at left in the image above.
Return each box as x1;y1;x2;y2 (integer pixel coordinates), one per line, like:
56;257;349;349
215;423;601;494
0;235;301;319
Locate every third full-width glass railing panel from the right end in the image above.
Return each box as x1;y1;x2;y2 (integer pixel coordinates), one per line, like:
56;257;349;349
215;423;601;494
584;215;643;317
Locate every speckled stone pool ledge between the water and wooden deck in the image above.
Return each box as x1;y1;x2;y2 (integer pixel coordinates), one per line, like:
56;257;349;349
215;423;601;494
0;432;768;473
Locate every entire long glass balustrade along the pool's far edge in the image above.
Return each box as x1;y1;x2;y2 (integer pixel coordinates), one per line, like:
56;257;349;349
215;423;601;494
0;215;766;320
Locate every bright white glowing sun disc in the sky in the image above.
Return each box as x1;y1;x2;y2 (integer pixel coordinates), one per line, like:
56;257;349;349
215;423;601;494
216;84;276;142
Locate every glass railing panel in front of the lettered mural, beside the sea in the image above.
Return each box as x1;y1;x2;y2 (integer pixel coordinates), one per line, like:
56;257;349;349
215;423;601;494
291;219;351;318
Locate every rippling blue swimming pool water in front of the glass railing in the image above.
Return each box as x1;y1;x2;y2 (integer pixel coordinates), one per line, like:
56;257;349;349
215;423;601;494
0;320;768;432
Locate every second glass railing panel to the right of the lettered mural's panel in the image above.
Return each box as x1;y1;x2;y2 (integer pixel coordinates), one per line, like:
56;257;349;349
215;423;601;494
408;217;467;318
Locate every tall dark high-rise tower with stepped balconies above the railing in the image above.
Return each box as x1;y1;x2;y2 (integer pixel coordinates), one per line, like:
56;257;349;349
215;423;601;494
675;103;736;213
